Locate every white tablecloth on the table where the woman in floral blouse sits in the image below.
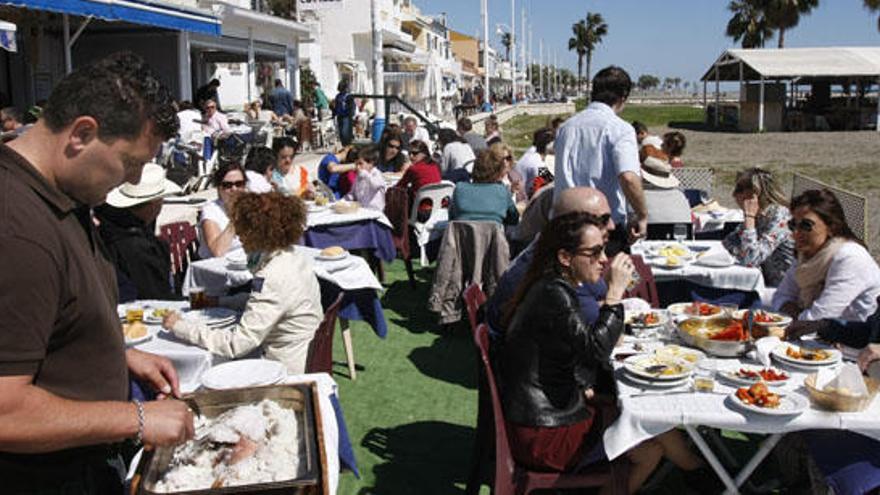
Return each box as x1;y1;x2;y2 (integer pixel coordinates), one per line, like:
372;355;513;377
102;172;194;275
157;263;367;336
632;241;764;291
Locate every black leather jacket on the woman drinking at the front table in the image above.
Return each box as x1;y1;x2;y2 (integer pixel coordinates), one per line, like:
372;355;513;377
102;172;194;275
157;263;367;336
498;276;623;427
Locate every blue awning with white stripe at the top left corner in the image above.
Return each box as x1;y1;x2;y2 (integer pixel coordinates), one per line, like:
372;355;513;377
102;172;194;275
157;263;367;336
0;0;220;36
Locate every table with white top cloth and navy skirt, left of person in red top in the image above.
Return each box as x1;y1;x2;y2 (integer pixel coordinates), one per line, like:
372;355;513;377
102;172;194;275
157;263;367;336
302;208;397;263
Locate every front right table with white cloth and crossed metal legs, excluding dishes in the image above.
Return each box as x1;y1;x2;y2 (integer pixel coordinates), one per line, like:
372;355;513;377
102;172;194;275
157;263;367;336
603;329;880;493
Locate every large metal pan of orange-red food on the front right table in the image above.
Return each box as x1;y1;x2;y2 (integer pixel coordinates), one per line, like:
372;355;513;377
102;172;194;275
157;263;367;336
678;317;749;357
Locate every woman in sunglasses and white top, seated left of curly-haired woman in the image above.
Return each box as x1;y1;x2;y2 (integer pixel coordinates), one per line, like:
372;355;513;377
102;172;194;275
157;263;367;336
198;162;247;259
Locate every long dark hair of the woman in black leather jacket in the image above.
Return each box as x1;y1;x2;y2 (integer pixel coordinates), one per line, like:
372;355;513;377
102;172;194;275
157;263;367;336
502;211;603;327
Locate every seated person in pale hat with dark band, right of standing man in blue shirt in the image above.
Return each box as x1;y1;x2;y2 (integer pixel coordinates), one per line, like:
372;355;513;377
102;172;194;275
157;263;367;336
642;146;691;229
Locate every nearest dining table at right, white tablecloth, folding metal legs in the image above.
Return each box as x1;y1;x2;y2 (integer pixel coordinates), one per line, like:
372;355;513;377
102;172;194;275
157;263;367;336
603;310;880;493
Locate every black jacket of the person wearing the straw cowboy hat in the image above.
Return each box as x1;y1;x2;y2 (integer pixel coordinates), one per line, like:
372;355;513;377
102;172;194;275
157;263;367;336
95;205;178;302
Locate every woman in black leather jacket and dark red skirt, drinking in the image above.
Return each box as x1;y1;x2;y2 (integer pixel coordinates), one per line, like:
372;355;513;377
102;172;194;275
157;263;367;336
497;212;703;493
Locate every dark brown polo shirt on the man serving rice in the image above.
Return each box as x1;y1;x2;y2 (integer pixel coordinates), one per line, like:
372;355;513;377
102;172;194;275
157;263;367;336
0;146;128;400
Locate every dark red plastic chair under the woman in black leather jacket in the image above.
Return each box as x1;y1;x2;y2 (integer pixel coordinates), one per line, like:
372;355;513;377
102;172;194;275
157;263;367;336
474;324;628;495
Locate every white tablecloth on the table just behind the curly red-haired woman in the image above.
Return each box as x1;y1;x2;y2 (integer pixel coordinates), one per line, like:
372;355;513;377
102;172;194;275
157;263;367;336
182;246;382;295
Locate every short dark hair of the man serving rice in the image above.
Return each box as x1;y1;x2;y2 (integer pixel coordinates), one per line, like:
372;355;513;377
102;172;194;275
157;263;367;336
42;52;179;141
